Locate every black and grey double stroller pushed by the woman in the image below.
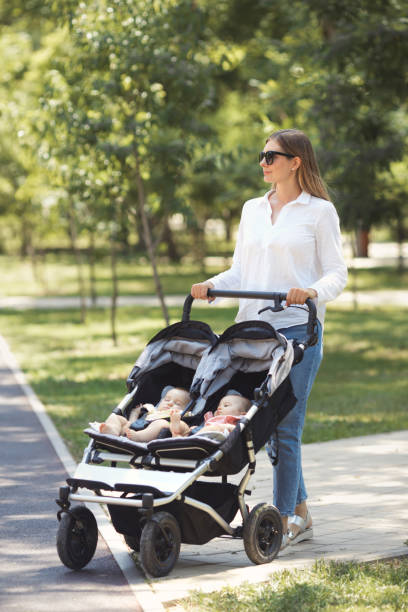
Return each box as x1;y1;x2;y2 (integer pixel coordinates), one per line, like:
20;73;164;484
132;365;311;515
57;290;316;577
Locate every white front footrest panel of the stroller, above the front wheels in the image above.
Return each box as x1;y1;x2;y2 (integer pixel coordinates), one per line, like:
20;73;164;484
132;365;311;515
71;463;188;495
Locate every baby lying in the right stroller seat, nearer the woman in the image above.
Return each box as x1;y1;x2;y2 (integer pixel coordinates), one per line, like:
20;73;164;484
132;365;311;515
170;390;251;438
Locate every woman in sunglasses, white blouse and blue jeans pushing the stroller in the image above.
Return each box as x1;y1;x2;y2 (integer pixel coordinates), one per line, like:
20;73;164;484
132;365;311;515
191;129;347;548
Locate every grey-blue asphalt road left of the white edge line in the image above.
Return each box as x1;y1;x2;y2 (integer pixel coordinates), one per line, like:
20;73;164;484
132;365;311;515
0;353;141;612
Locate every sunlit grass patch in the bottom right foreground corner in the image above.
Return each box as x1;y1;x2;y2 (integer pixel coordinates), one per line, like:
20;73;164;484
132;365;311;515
180;558;408;612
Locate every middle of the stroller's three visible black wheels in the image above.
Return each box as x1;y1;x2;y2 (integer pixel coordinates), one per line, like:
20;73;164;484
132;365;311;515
140;512;181;577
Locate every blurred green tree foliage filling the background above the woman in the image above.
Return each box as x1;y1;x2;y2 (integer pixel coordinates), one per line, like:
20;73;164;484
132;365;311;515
0;0;408;259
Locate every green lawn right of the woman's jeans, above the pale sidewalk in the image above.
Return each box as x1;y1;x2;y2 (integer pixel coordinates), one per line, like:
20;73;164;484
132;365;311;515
304;307;408;442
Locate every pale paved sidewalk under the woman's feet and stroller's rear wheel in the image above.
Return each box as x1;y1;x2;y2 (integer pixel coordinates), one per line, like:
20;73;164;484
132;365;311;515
152;431;408;608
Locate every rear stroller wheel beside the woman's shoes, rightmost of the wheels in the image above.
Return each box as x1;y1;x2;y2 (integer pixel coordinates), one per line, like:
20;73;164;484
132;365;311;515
243;504;282;565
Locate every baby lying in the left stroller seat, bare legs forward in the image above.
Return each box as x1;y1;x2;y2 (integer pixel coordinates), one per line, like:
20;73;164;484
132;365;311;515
99;387;190;442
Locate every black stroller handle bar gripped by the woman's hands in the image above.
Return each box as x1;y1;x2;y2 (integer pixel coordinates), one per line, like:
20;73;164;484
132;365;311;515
182;289;317;347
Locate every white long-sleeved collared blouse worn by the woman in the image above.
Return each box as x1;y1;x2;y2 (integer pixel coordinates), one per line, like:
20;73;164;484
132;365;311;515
209;191;347;329
